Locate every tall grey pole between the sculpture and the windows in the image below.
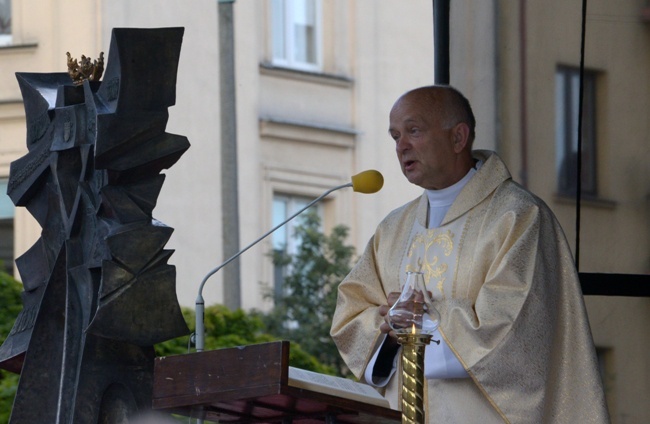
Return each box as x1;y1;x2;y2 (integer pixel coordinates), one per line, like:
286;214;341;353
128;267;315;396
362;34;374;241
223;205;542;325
218;0;241;310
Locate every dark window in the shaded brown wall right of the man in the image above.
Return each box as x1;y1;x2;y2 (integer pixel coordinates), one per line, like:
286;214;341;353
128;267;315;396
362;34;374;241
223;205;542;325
555;67;598;197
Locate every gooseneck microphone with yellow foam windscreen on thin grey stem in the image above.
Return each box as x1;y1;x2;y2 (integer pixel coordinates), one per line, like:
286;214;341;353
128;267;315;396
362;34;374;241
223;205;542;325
194;169;384;352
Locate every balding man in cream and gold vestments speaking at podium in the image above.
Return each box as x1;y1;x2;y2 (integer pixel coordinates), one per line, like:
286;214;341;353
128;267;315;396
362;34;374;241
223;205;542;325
331;86;609;424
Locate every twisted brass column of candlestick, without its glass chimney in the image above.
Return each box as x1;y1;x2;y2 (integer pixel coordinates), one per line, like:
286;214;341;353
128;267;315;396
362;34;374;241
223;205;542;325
397;333;431;424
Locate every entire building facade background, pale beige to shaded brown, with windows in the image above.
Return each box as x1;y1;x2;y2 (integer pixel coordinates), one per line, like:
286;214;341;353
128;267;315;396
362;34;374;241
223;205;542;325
0;0;650;424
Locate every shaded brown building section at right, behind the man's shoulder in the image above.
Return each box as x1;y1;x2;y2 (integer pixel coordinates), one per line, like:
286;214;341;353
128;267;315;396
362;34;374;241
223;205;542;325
497;0;650;423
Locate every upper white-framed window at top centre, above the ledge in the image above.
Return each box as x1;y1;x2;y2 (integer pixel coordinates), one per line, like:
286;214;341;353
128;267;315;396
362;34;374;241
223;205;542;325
271;0;321;70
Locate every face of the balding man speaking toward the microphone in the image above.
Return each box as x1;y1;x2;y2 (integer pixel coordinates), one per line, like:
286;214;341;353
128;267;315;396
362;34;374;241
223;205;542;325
388;93;458;190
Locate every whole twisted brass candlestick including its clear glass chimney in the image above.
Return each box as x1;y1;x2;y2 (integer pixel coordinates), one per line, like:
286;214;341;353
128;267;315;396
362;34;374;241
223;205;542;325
388;272;440;424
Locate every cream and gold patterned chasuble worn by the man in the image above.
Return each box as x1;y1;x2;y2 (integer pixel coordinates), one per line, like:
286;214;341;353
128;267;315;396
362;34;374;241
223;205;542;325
331;151;609;424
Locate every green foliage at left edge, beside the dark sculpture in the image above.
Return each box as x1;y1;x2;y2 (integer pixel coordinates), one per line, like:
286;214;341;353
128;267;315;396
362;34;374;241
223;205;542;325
0;271;23;424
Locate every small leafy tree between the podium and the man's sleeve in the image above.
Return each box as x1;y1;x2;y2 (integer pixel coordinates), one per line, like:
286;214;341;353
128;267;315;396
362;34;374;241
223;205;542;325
254;212;354;376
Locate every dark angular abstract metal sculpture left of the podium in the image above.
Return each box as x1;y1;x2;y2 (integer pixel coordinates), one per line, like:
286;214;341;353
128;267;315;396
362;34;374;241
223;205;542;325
0;28;189;424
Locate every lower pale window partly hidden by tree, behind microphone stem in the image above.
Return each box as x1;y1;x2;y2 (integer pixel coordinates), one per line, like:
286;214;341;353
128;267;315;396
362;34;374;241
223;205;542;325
272;194;321;298
